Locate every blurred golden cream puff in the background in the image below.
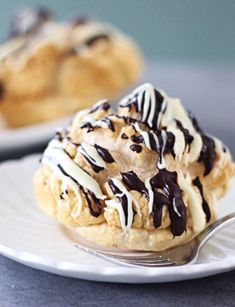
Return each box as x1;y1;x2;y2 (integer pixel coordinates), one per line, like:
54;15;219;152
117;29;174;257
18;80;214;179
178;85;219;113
0;9;142;127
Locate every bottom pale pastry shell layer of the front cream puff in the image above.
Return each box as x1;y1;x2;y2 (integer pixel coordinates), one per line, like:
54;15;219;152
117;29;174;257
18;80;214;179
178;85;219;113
66;223;196;251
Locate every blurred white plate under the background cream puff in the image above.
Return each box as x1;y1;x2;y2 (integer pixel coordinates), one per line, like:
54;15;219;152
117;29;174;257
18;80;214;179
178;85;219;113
0;116;71;152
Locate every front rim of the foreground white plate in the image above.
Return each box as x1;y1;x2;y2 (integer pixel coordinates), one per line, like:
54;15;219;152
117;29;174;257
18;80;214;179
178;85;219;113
0;243;235;284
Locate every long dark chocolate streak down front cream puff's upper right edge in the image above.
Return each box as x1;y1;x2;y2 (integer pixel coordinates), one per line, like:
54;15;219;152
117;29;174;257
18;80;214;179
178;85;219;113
189;114;216;176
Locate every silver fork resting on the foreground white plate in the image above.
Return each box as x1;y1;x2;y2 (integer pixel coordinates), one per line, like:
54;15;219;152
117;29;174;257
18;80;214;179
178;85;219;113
74;213;235;267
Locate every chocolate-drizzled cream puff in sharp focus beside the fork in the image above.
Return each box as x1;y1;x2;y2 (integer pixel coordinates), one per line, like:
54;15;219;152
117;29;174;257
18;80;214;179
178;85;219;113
34;83;234;251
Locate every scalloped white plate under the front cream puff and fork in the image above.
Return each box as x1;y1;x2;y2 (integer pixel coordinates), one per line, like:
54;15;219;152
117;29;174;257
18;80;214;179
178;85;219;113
0;155;235;283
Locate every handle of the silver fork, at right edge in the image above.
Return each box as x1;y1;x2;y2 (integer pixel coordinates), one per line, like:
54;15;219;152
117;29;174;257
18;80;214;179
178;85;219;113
198;212;235;248
